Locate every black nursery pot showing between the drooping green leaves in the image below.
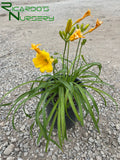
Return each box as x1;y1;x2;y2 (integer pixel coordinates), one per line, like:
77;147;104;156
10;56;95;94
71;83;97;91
46;79;82;129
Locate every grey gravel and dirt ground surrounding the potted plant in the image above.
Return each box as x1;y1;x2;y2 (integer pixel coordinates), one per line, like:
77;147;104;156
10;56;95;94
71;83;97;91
0;0;120;160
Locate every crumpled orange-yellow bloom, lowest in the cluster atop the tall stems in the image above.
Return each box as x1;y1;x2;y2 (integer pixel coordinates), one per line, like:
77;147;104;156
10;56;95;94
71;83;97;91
69;29;85;41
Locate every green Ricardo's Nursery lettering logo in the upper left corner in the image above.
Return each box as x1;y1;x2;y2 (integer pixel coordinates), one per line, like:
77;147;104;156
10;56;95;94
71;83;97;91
1;2;54;21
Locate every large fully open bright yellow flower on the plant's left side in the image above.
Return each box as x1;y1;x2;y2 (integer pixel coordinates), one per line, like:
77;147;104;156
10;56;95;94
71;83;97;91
33;50;54;73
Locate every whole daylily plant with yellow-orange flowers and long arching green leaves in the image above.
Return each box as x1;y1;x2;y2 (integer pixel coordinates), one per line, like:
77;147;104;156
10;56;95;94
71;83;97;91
0;9;117;151
